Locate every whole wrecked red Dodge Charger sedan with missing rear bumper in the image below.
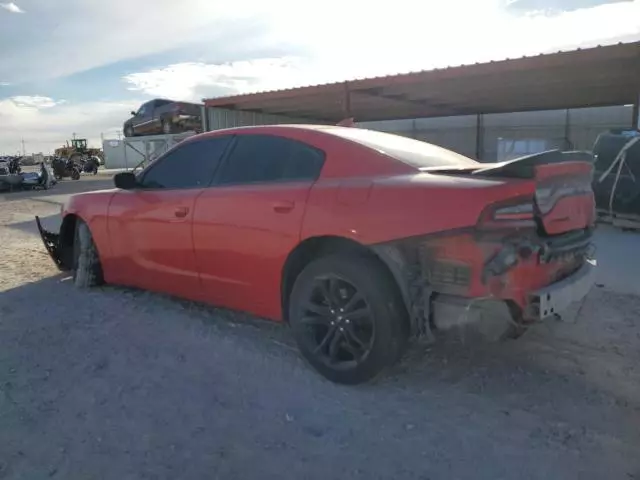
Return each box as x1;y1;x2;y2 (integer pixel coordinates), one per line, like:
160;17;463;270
36;125;595;384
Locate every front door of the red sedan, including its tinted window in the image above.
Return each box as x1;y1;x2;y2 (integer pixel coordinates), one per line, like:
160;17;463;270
109;137;231;300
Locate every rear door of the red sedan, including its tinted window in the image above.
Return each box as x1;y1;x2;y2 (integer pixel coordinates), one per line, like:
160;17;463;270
193;134;324;318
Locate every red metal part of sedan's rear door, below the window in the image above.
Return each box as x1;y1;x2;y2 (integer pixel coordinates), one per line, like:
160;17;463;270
193;182;313;319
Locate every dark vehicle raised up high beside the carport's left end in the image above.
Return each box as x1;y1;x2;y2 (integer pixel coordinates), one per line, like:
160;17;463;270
123;98;202;137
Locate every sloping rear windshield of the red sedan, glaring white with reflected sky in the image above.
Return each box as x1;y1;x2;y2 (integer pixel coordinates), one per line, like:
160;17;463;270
331;128;478;168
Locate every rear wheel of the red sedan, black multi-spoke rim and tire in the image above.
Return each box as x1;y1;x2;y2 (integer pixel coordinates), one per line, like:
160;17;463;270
289;254;408;385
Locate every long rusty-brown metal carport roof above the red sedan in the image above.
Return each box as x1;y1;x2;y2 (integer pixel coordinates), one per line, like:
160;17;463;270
204;42;640;122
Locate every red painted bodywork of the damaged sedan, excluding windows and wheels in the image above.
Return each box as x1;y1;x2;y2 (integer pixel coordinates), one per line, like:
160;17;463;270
52;126;595;328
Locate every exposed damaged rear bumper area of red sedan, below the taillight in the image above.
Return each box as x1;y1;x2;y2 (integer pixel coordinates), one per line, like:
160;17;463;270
372;228;593;339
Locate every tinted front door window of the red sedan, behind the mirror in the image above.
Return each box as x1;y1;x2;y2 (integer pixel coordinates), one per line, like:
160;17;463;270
141;136;232;189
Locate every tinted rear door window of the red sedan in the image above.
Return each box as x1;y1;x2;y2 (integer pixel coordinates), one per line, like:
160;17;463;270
218;135;324;185
